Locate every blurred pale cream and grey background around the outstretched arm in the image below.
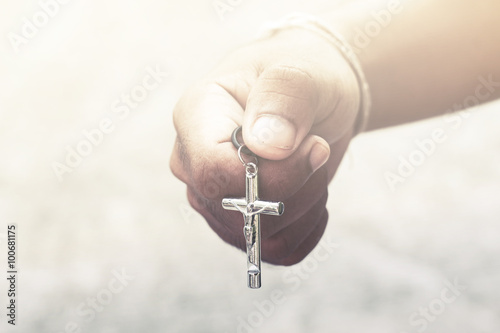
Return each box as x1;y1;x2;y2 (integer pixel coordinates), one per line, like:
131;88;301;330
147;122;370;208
0;0;500;333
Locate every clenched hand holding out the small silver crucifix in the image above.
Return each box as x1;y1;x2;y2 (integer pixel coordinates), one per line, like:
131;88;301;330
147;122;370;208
170;28;360;265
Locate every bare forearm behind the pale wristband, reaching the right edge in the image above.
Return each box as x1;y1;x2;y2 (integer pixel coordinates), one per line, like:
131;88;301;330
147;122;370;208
327;0;500;130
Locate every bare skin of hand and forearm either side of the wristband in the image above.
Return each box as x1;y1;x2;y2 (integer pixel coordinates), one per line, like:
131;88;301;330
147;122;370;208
171;0;500;265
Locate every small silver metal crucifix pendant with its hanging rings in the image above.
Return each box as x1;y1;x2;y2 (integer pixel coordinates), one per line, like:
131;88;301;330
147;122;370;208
222;126;285;289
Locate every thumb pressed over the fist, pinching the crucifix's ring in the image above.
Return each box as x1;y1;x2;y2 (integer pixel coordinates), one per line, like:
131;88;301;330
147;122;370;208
242;65;328;160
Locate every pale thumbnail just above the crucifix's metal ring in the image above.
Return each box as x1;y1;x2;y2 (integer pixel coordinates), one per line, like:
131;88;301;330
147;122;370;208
252;115;297;149
